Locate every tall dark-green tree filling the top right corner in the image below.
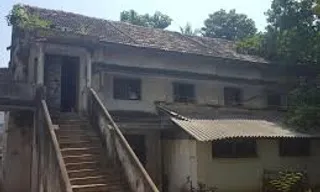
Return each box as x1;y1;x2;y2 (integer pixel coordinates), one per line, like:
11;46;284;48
266;0;319;64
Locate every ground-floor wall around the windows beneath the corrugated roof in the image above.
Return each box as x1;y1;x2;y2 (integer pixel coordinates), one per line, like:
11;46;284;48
197;139;320;192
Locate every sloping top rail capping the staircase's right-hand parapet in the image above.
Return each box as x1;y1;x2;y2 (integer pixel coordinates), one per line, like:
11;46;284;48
90;88;159;192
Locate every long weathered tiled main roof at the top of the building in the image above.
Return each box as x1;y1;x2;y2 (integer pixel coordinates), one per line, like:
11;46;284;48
24;5;268;63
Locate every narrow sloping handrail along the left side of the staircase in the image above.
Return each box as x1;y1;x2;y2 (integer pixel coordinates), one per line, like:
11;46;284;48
41;100;72;192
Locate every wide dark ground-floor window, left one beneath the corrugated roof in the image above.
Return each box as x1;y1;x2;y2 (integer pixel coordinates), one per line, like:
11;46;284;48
212;139;257;158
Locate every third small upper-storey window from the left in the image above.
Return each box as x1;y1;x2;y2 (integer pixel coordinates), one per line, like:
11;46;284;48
224;87;242;106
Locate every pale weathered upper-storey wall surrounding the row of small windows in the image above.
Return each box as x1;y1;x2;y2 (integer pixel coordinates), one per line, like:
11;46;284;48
92;71;266;112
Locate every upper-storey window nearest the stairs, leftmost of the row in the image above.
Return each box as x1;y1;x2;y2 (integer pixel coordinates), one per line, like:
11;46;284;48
113;78;141;100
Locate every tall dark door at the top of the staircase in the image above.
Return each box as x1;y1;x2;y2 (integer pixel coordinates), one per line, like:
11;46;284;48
60;57;79;112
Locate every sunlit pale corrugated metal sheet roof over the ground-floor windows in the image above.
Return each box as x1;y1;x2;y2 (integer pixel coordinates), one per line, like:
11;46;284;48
171;117;319;141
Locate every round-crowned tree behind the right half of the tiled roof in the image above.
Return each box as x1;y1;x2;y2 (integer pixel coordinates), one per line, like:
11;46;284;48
202;9;257;40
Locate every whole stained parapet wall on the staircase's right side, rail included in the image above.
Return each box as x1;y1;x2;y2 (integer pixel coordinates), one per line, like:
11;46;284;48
88;89;159;192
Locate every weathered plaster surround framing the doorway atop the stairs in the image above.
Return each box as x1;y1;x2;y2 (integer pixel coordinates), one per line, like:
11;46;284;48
27;43;91;112
